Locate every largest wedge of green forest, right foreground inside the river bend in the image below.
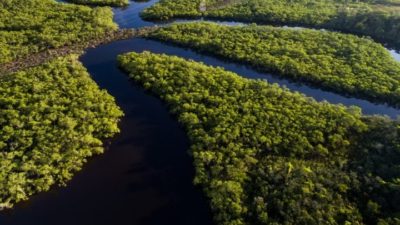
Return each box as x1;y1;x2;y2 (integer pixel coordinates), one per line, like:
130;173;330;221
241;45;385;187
119;52;400;225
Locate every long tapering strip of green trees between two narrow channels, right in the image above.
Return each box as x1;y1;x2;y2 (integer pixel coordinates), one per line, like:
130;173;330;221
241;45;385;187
149;23;400;106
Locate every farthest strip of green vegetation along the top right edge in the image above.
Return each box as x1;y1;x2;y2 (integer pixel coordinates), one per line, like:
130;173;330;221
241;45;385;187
142;0;400;47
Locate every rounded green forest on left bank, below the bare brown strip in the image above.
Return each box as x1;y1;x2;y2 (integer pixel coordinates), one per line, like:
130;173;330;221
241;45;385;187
0;56;122;208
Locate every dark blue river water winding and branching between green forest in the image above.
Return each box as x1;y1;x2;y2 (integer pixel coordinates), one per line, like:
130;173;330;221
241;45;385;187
0;0;400;225
